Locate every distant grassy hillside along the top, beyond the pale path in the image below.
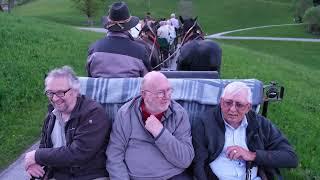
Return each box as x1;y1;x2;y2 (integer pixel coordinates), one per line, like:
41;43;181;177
14;0;292;33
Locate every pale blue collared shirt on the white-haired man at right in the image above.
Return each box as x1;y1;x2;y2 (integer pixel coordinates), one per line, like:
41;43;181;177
210;117;260;180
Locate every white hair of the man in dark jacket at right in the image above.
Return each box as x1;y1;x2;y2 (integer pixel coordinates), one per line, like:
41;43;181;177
221;81;252;104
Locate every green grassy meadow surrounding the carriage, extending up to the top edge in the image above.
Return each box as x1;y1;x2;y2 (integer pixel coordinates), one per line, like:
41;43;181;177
0;0;320;180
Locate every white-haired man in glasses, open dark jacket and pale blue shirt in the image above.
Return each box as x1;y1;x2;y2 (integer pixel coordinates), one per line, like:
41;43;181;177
192;82;298;180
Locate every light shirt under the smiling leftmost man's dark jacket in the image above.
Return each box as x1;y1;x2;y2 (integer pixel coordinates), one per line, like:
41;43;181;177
51;109;67;148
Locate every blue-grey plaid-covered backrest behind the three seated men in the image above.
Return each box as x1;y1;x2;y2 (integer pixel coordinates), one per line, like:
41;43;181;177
80;77;263;124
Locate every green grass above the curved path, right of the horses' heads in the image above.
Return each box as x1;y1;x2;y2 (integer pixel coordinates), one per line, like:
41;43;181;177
193;0;292;34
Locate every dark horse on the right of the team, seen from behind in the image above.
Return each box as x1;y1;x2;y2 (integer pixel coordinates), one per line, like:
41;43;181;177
177;16;222;74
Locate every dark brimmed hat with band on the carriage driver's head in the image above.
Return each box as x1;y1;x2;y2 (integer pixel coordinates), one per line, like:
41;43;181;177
105;2;139;31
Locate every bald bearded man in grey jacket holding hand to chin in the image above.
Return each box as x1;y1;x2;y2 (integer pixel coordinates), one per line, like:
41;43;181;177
106;71;194;180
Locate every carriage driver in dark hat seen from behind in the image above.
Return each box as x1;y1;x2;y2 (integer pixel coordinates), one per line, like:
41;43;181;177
86;2;151;78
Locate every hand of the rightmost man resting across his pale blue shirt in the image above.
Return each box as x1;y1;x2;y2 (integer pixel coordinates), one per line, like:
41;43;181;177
226;146;256;161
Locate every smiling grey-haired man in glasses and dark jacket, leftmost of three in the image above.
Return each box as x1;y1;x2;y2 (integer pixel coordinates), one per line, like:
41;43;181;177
25;66;111;180
